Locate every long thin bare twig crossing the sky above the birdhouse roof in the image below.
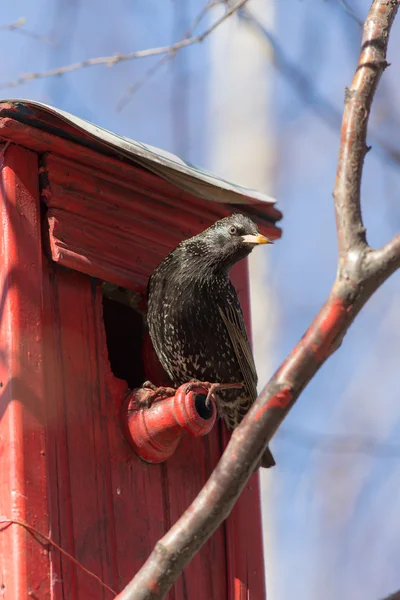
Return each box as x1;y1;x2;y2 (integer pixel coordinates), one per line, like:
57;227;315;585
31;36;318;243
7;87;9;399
0;0;248;90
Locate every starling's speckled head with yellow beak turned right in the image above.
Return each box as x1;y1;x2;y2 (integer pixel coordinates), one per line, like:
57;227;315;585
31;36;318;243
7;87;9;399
181;214;273;271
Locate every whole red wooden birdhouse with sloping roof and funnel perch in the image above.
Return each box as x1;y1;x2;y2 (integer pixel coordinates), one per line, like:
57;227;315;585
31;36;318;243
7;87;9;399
0;100;281;600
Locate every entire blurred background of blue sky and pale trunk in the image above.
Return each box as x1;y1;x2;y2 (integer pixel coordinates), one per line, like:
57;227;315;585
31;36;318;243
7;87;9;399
0;0;400;600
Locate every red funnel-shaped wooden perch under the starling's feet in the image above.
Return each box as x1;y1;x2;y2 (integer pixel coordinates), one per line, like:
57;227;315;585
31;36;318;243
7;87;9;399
122;383;217;463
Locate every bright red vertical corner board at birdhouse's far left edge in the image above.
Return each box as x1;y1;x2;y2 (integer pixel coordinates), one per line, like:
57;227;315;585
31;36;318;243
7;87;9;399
0;145;51;600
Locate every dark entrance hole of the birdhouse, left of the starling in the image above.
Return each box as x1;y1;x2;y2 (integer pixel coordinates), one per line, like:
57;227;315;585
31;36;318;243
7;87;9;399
102;283;145;388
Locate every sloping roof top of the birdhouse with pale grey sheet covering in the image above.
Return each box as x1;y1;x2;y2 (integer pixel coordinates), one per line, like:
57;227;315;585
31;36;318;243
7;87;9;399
0;99;281;222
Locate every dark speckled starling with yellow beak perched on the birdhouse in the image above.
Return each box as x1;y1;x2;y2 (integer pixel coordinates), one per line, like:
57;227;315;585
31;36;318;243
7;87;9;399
147;214;275;467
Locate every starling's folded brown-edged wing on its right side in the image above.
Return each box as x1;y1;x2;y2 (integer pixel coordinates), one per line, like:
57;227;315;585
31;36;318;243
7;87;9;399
218;286;257;398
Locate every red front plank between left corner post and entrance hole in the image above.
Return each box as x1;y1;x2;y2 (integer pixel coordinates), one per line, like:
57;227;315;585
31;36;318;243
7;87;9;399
47;269;117;599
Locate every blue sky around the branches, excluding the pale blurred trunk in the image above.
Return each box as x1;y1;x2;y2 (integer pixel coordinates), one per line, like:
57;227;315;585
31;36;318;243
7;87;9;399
0;0;400;600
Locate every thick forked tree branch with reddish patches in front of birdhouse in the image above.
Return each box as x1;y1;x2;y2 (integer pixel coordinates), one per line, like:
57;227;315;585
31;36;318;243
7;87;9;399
117;0;400;600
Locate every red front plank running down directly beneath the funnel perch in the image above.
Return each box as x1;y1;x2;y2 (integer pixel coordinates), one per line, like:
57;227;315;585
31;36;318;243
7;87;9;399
97;288;168;589
